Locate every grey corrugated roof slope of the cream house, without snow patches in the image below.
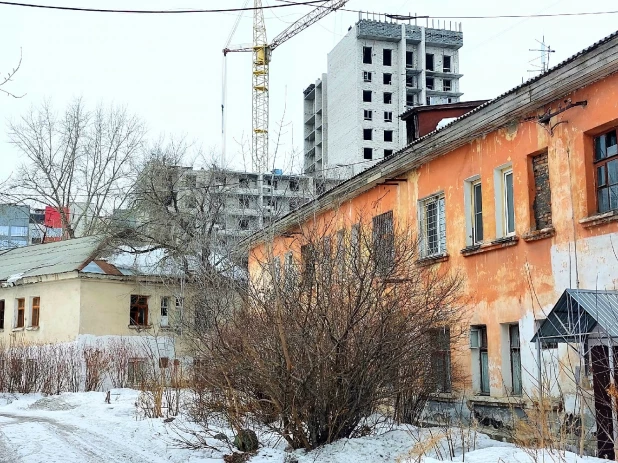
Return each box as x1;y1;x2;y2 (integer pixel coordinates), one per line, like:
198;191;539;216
0;236;103;281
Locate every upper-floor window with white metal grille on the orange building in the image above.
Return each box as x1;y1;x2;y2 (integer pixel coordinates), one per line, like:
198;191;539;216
419;194;446;257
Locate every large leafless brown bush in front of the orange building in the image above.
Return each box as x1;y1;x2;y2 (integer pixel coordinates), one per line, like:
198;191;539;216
187;218;462;449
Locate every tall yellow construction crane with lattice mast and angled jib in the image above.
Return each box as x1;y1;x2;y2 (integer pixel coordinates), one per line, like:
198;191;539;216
223;0;348;172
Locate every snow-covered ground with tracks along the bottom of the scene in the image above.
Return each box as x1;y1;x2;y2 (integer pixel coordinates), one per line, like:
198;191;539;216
0;389;601;463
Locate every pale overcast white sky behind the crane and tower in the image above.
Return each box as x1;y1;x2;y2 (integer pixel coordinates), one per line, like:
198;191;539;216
0;0;618;184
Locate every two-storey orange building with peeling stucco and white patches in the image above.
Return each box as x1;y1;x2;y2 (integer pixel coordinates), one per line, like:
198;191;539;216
249;30;618;452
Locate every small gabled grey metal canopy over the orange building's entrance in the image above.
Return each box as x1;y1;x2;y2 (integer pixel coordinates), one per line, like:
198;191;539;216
532;289;618;342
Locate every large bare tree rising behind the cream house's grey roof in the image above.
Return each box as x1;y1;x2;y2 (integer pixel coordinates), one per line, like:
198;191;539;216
7;99;145;238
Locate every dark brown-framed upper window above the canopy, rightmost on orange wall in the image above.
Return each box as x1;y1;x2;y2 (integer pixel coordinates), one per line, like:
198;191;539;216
594;129;618;213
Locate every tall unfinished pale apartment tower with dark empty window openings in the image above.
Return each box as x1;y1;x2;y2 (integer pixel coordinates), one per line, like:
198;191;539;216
304;19;463;178
